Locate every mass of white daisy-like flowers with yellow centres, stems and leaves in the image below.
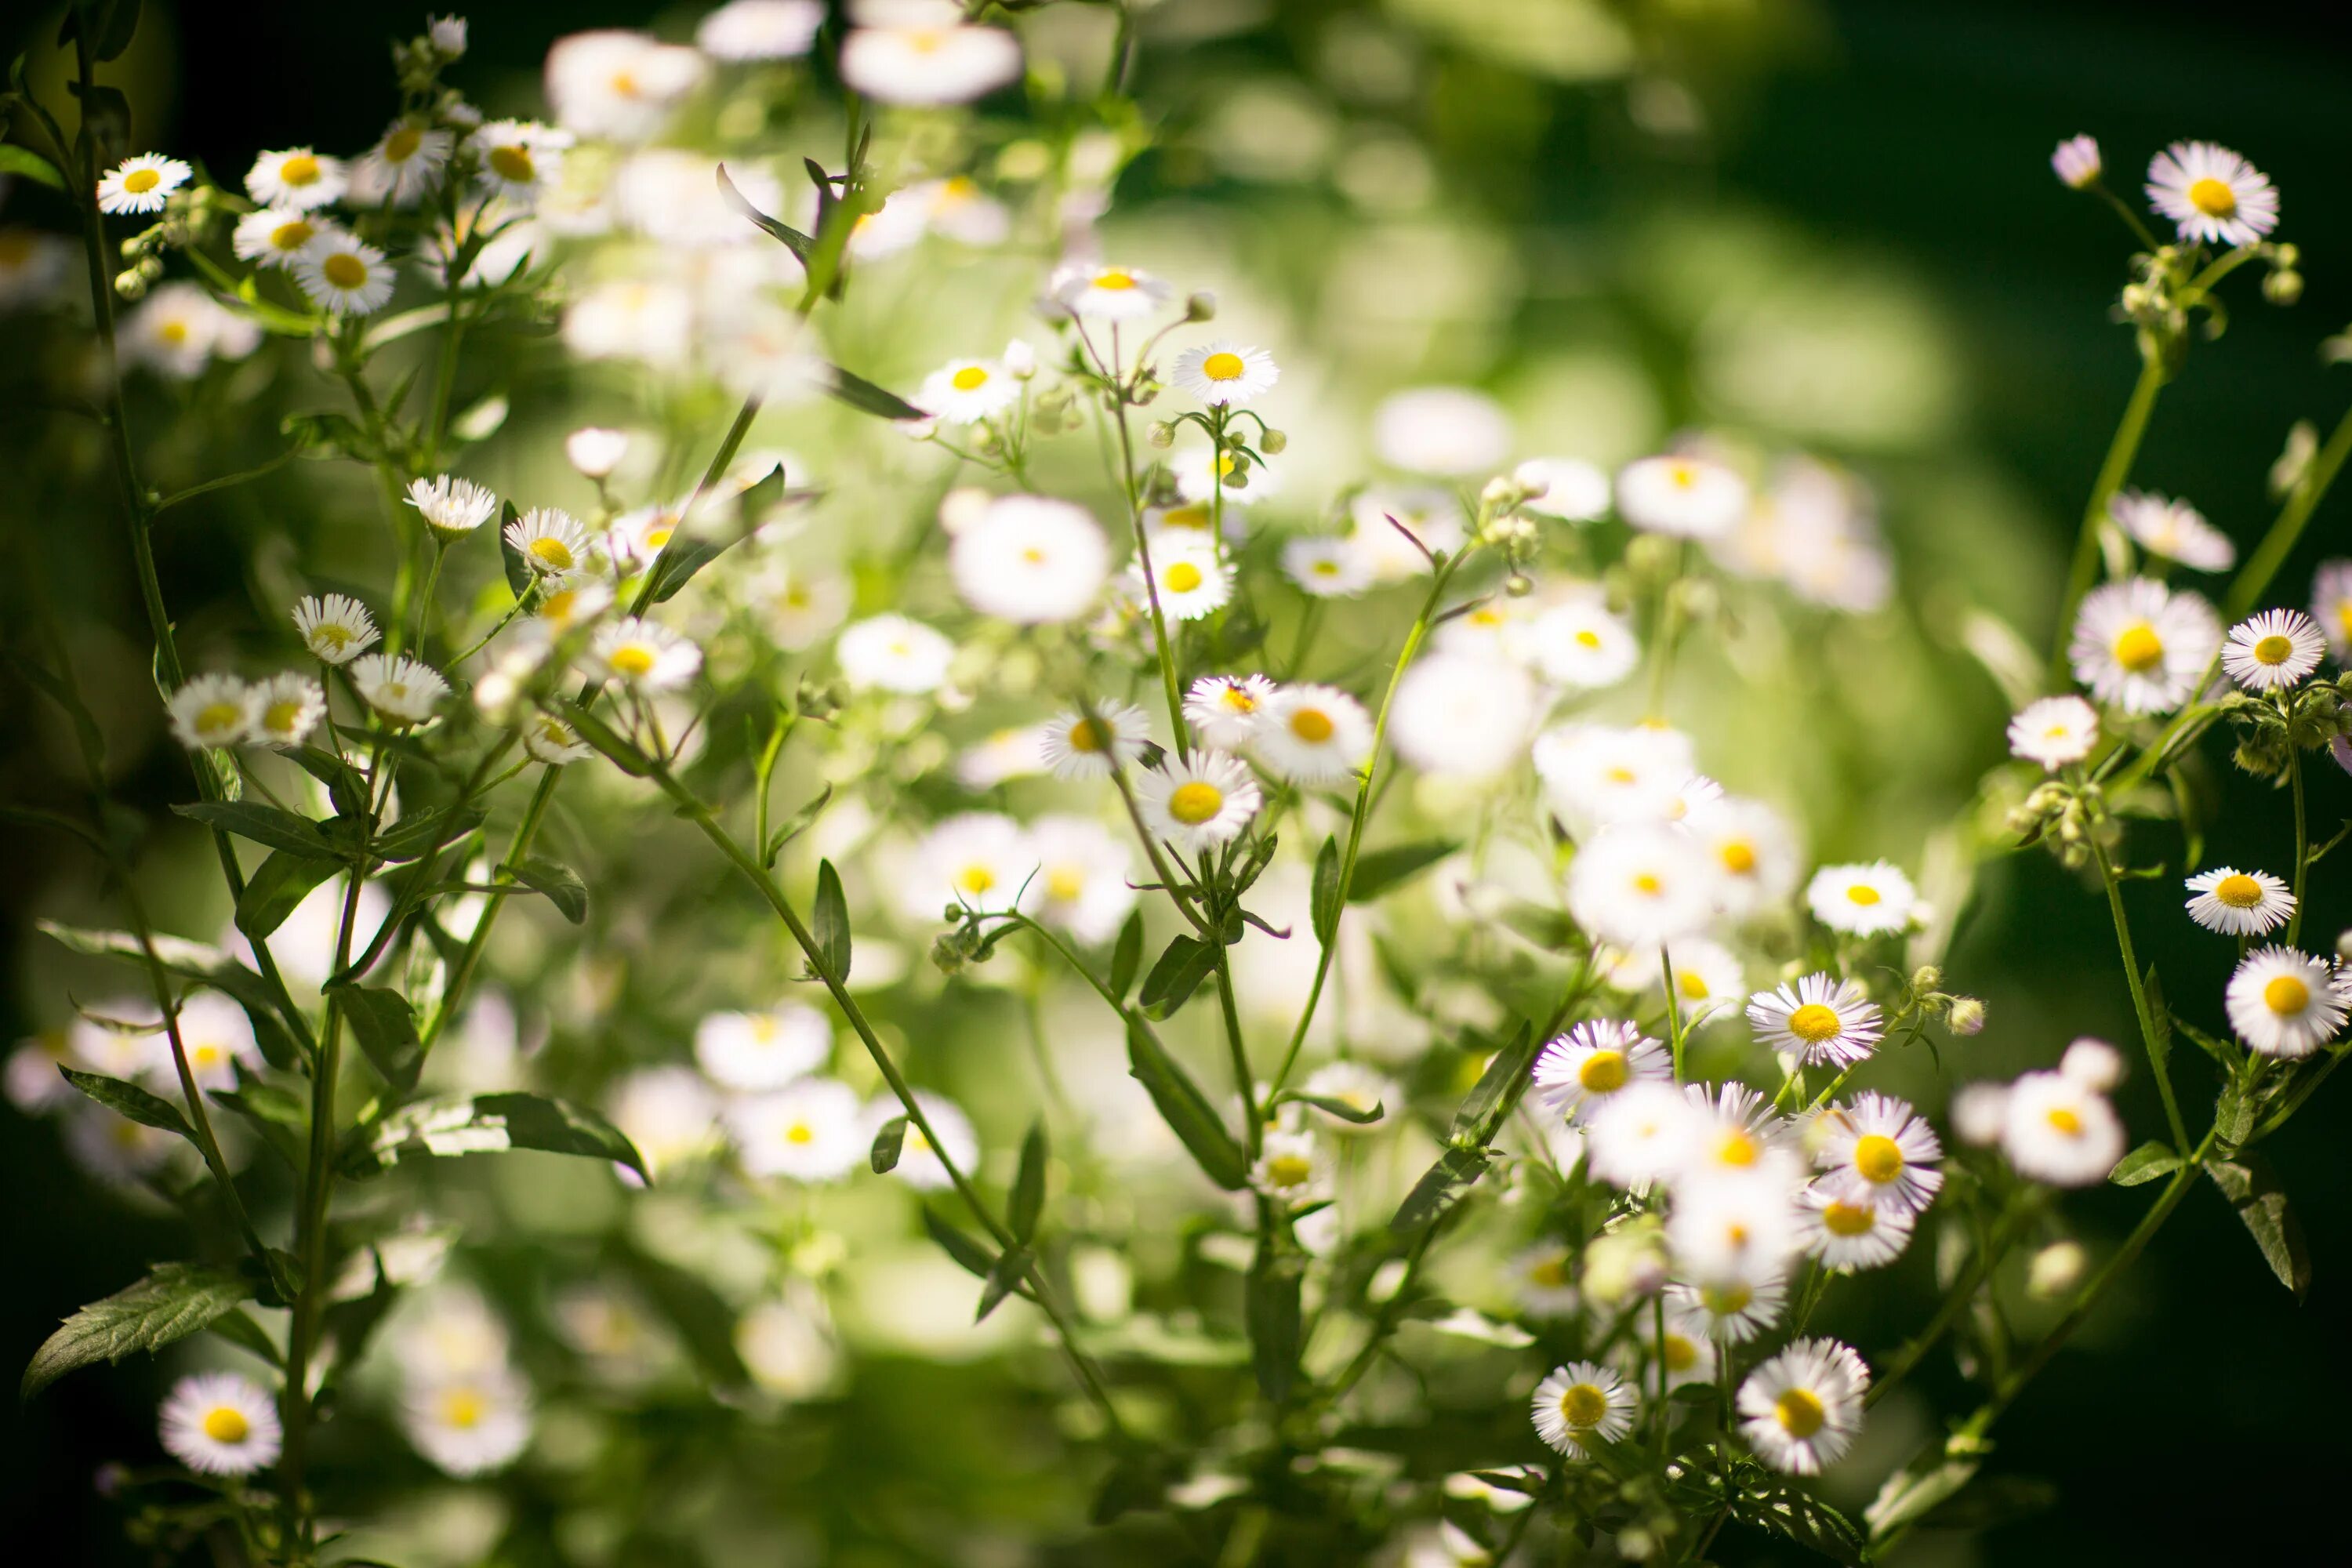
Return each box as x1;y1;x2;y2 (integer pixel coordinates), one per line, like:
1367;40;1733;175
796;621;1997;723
7;0;2352;1563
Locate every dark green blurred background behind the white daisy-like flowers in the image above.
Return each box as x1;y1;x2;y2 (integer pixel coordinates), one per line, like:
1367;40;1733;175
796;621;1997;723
0;0;2352;1563
